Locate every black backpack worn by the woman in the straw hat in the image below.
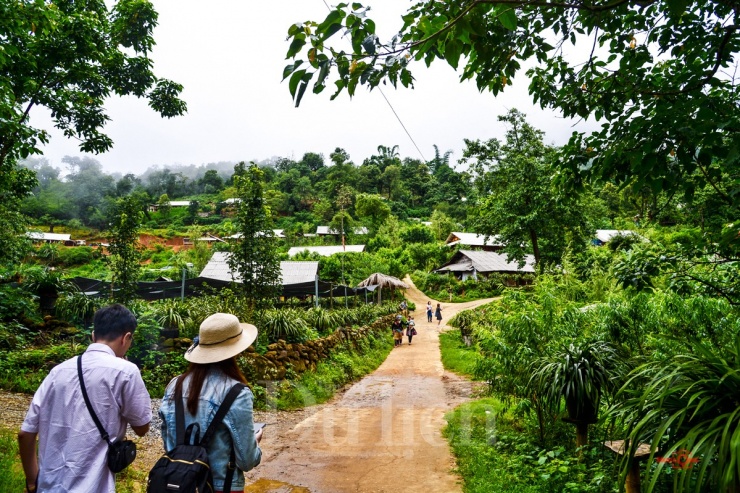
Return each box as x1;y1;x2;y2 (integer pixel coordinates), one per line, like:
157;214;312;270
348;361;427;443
146;376;245;493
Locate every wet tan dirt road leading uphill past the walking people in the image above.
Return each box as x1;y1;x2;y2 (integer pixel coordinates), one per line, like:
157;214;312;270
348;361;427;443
0;279;498;493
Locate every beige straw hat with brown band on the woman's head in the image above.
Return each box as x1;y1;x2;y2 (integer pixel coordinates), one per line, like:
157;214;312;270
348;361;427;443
185;313;257;364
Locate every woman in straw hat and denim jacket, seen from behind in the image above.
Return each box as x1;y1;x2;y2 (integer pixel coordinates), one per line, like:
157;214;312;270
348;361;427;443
159;313;262;493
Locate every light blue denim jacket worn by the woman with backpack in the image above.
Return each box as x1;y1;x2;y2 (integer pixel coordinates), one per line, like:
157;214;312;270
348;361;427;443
159;369;262;491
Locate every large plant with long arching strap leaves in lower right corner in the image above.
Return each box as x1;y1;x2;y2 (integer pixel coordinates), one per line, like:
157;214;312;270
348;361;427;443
610;338;740;493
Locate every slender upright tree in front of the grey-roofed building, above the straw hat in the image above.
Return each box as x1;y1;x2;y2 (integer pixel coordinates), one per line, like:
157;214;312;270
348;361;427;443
229;162;281;311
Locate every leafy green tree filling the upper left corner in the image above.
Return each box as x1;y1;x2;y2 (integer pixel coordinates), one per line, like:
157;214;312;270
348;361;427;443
0;0;186;264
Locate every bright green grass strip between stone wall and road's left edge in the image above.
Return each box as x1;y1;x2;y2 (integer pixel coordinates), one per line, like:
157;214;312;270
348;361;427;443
264;333;393;411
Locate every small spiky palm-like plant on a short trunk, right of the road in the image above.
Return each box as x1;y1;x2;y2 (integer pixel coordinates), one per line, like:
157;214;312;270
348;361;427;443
530;341;623;446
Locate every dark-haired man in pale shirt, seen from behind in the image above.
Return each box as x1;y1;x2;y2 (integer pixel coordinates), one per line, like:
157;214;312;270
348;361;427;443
18;304;152;493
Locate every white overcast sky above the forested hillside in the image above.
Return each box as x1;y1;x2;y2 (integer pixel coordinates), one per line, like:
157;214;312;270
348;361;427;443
36;0;600;173
